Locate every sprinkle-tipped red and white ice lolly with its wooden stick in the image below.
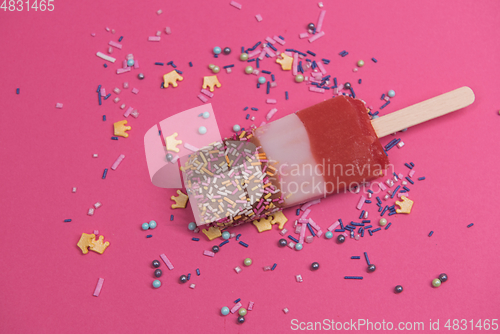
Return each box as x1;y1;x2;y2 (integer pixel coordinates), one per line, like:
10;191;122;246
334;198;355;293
145;87;474;228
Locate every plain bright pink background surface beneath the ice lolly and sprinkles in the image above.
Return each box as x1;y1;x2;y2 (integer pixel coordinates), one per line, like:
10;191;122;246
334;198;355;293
0;0;500;333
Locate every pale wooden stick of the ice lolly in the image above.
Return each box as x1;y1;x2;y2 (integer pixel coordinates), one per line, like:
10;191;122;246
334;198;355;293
372;86;475;138
